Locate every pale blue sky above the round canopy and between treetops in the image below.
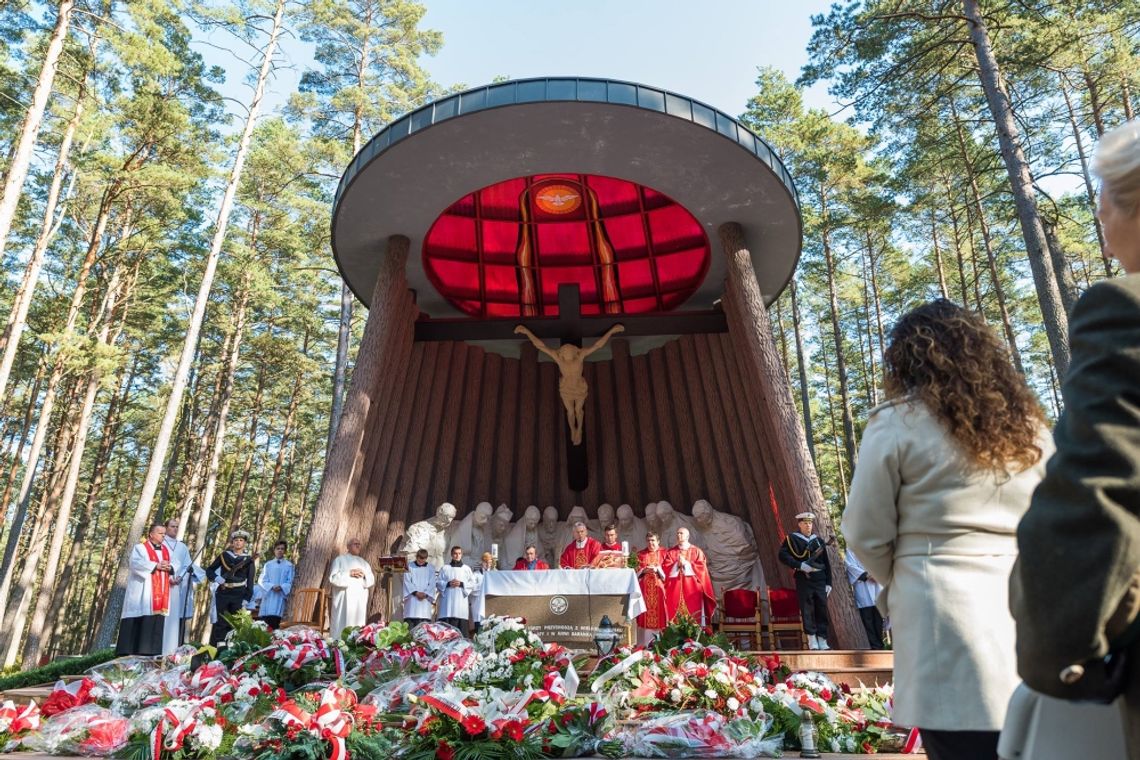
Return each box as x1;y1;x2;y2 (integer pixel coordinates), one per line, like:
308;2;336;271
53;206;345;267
209;0;837;124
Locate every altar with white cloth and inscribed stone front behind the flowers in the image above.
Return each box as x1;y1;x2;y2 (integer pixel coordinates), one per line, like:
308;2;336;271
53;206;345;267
483;569;645;648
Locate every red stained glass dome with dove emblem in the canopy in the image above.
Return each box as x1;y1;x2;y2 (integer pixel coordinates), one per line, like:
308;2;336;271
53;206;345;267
423;174;709;318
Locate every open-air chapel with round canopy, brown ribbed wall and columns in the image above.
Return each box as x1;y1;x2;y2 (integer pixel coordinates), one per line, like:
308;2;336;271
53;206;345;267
294;77;866;648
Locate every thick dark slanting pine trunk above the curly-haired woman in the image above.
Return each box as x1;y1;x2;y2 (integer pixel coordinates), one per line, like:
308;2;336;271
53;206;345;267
962;0;1069;377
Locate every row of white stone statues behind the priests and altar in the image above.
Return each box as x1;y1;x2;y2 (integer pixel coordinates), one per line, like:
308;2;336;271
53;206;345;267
404;499;764;597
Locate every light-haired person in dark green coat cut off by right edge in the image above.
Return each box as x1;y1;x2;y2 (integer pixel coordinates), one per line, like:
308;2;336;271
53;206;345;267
1010;121;1140;760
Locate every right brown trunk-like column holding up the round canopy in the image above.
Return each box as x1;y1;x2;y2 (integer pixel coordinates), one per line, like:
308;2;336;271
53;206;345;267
718;222;868;648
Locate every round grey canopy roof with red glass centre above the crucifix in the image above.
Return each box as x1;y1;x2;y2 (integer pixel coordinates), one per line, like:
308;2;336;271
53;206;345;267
332;77;801;319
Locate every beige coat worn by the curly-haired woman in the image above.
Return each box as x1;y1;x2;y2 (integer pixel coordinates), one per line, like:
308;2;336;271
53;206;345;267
842;400;1052;730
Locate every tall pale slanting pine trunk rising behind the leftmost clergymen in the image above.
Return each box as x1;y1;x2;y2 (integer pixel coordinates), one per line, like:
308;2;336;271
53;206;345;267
99;0;285;645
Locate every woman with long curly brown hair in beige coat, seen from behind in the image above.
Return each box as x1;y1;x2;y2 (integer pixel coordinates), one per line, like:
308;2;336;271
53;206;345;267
842;300;1052;760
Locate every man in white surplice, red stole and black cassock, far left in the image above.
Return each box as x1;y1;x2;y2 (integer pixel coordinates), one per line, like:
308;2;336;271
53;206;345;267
115;523;173;656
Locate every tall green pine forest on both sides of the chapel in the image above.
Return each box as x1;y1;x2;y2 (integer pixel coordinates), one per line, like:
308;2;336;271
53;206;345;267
0;0;1140;668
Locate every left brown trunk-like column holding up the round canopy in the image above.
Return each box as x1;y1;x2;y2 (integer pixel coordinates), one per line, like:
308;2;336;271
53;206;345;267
293;235;409;610
